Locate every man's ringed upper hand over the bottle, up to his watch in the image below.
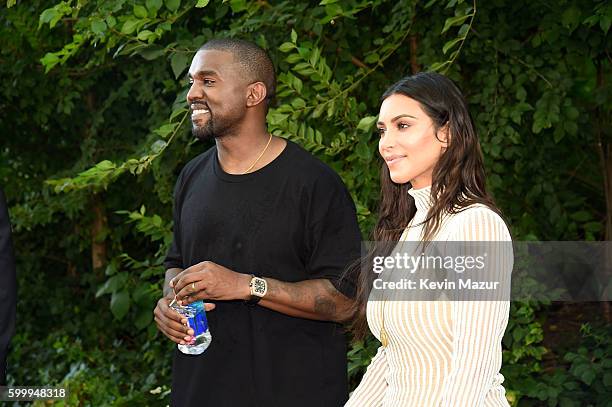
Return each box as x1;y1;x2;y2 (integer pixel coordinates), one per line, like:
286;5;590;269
170;261;251;305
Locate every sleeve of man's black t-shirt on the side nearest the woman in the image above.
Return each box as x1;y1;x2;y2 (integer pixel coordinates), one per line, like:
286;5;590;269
306;169;361;298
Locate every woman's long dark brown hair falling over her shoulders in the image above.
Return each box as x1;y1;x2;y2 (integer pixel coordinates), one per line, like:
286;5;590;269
349;72;501;339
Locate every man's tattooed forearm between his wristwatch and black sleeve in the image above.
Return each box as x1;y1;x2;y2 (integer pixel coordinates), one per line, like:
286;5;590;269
259;278;353;322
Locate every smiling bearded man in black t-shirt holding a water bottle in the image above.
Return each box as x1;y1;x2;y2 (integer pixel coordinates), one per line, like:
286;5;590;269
155;40;360;407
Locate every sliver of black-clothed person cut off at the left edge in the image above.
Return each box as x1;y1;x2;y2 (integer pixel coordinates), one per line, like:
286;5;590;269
0;190;17;385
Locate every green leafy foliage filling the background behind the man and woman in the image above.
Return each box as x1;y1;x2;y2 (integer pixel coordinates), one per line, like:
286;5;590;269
0;0;612;406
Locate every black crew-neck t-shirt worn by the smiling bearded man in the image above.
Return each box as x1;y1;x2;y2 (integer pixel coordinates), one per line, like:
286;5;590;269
165;142;360;407
